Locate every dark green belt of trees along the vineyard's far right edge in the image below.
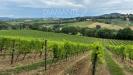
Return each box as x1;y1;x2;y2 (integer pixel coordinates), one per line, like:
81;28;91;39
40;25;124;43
60;27;133;40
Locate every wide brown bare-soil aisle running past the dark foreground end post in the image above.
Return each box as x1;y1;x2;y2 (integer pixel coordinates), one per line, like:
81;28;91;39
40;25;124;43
18;54;110;75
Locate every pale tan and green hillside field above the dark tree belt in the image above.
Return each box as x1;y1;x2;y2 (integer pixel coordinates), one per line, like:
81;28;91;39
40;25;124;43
65;21;133;30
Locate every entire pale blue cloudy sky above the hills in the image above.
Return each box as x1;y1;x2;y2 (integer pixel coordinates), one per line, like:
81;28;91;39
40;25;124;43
0;0;133;18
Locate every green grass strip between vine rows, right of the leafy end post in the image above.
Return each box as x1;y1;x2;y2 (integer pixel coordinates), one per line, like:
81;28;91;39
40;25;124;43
105;51;125;75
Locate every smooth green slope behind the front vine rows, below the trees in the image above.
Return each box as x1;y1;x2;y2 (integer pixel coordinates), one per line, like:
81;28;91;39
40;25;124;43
0;30;98;43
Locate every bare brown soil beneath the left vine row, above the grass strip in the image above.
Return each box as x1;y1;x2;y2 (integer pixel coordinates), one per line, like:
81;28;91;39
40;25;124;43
0;54;51;71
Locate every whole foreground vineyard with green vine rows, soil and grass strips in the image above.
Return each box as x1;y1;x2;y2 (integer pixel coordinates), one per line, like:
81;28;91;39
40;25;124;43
0;30;133;75
